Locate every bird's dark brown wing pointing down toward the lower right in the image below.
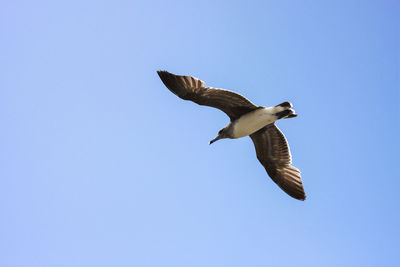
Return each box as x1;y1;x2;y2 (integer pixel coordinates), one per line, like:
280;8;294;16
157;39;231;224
250;124;306;200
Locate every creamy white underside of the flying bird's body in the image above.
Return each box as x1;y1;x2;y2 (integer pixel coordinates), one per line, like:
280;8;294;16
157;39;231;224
233;107;277;138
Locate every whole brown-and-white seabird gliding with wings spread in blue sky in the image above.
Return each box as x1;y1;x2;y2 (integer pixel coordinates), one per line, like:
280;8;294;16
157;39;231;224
157;70;306;200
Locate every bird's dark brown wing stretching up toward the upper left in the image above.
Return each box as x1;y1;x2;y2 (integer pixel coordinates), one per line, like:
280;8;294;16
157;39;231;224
157;71;258;121
